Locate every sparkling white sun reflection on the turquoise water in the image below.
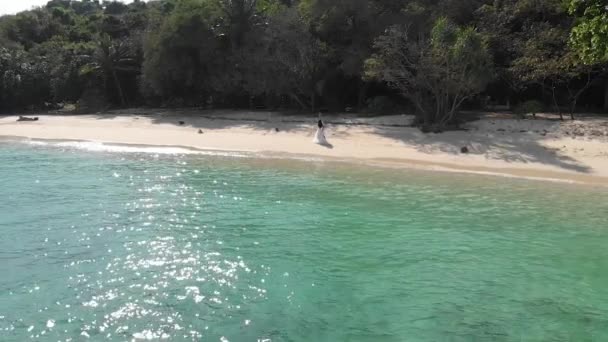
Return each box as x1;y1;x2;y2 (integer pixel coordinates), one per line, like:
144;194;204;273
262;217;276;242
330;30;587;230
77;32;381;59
54;164;266;341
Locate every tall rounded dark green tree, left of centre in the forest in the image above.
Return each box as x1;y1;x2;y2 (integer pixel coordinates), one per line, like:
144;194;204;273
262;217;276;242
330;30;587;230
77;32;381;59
142;0;225;102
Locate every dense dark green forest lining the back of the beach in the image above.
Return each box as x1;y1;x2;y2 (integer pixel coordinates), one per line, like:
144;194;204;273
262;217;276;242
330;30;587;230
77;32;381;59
0;0;608;126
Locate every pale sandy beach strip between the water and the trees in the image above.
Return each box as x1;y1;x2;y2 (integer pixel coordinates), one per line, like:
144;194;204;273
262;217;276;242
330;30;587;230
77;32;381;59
0;109;608;185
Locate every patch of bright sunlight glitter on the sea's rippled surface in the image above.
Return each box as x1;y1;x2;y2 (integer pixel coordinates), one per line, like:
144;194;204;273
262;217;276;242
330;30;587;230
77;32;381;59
0;154;263;339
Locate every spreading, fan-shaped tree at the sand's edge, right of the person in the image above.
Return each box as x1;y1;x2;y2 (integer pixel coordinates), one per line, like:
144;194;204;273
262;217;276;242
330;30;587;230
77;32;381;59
366;18;493;130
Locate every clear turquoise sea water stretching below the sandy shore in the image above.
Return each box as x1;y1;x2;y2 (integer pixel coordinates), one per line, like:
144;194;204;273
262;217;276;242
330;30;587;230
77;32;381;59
0;143;608;342
